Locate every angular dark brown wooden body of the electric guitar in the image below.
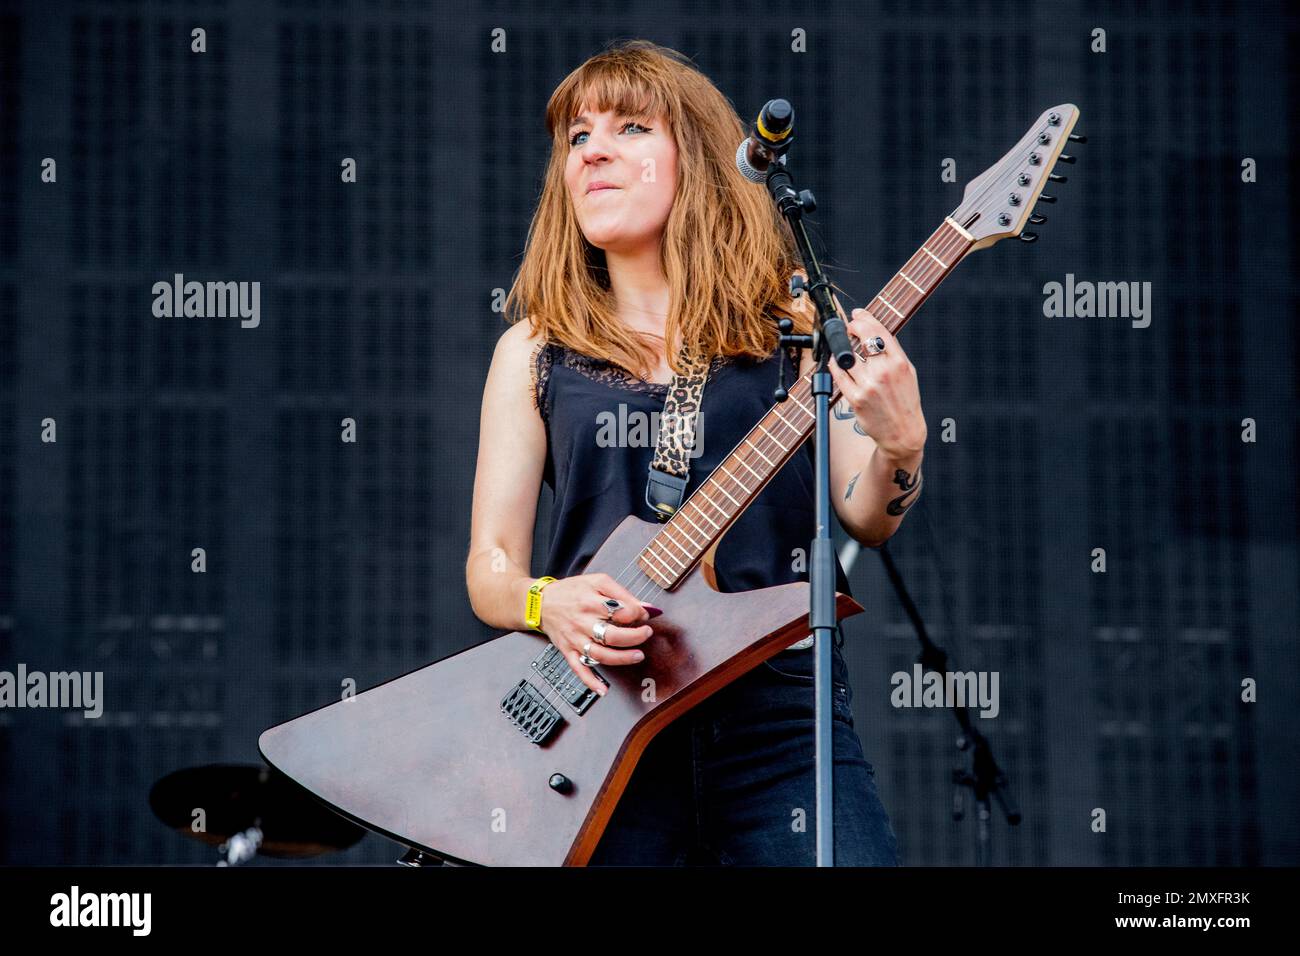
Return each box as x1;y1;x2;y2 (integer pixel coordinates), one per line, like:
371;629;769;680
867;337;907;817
259;515;863;866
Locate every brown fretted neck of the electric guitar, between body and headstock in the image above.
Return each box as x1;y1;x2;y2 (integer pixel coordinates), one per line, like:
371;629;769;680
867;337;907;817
637;217;975;591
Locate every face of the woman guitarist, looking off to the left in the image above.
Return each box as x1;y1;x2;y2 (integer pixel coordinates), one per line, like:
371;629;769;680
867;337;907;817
564;108;677;252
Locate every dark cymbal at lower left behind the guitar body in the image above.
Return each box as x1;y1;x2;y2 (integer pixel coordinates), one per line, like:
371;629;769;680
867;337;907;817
150;763;365;858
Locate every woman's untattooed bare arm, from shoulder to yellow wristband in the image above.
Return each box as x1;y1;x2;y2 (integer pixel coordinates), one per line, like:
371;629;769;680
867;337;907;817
465;321;546;631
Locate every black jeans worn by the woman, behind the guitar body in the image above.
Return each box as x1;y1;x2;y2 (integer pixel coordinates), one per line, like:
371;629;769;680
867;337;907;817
589;646;898;866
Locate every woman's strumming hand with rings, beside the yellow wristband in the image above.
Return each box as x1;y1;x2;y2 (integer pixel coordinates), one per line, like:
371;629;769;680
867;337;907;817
541;574;658;697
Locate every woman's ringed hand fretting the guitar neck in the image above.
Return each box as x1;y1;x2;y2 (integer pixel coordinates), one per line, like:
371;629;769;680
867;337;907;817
827;308;926;460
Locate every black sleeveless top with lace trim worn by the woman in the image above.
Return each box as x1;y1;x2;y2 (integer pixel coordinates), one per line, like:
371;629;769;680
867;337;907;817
532;342;852;594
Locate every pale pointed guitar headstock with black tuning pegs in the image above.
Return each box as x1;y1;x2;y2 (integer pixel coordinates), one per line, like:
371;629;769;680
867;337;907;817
950;103;1087;248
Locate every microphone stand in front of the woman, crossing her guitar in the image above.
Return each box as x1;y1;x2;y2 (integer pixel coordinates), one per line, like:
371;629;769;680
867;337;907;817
764;152;855;866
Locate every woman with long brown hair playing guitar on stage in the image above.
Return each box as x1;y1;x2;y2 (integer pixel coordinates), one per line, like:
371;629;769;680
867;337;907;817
465;40;926;866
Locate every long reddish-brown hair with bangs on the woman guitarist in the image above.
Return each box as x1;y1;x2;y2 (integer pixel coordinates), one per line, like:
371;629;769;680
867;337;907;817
506;40;811;377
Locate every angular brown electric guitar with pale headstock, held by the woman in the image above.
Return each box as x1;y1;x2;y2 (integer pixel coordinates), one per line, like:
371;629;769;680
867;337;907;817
259;103;1083;866
